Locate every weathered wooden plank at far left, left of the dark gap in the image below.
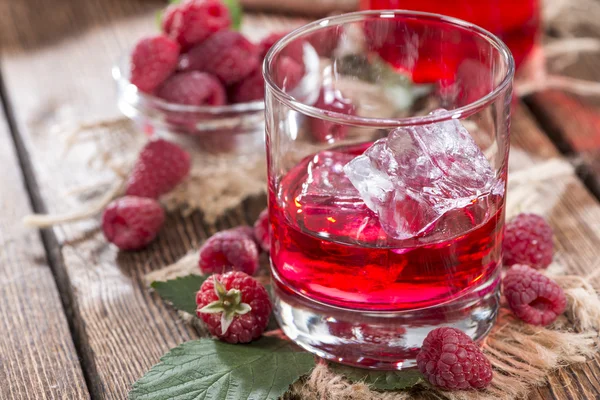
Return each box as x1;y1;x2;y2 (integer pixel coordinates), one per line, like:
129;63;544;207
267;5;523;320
0;88;89;400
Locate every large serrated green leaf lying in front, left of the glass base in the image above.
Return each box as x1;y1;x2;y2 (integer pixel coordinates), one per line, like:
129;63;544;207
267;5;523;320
129;336;315;400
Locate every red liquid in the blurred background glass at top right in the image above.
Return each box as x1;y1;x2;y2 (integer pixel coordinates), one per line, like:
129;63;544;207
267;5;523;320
360;0;540;68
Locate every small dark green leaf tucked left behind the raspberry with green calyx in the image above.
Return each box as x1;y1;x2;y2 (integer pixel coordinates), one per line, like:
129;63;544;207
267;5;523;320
150;275;208;315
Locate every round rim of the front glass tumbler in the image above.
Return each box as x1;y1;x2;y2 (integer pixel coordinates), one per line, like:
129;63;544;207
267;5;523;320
262;10;515;128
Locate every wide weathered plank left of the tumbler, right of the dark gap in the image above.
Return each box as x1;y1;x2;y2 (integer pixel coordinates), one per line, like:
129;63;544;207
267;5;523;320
0;0;276;400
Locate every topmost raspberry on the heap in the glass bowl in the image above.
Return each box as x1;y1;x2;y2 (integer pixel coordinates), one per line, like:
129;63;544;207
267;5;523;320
162;0;231;50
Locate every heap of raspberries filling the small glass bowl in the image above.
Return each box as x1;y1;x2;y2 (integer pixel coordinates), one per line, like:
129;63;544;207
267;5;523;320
130;0;304;106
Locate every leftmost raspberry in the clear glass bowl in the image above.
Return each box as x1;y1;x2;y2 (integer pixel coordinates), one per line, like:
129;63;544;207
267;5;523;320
131;35;179;93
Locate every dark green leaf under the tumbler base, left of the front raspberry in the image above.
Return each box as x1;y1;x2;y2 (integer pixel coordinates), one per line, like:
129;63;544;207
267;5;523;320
329;363;424;391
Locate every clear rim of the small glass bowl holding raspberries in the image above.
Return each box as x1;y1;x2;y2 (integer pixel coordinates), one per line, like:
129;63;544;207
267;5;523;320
112;51;265;116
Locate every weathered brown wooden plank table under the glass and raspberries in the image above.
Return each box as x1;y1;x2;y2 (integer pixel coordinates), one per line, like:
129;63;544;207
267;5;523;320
0;0;600;399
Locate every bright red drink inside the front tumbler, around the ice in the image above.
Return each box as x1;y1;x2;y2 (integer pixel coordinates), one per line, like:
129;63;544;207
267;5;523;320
269;143;504;310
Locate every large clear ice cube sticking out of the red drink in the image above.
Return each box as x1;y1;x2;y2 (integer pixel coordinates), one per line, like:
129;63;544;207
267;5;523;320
344;110;503;240
